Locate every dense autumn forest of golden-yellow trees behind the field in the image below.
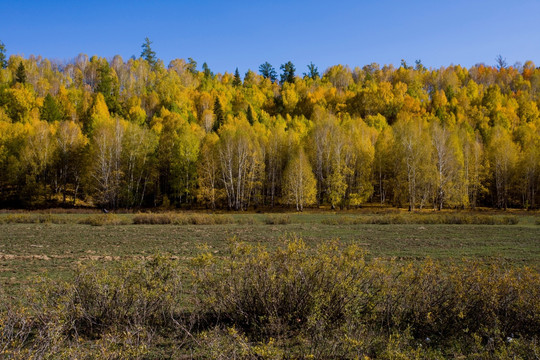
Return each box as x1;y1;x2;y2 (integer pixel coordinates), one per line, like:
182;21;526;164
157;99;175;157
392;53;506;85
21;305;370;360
0;38;540;211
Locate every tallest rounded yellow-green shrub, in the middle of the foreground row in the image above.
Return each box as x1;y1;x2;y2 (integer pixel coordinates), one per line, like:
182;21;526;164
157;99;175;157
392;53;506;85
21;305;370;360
194;238;371;336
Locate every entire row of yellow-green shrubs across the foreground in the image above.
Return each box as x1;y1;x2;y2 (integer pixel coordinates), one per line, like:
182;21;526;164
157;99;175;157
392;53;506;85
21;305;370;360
0;238;540;359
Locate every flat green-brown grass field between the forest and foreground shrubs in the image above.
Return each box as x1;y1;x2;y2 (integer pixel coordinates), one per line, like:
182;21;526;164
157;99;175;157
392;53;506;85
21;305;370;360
0;212;540;290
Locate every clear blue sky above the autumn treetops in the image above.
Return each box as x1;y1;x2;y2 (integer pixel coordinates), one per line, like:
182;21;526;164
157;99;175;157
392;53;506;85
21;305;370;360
0;0;540;73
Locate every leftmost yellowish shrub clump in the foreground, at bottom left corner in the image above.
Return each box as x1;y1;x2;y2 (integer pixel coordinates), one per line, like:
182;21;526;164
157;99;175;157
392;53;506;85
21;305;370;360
0;256;181;359
